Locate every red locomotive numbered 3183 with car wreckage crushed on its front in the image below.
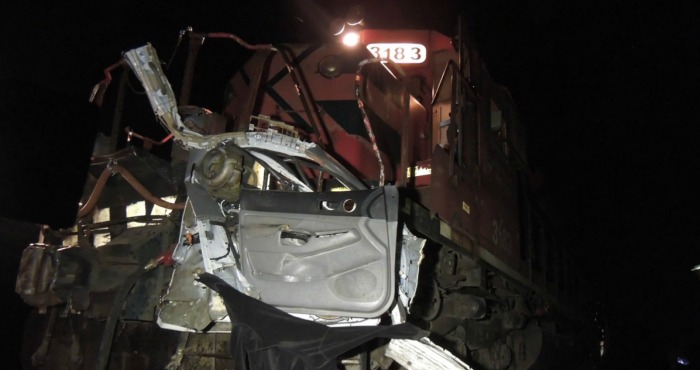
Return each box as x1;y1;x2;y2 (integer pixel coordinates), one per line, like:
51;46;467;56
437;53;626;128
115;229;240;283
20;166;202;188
16;10;606;370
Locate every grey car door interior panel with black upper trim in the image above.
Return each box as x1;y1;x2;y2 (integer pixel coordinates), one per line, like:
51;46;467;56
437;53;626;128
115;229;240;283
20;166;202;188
237;186;399;318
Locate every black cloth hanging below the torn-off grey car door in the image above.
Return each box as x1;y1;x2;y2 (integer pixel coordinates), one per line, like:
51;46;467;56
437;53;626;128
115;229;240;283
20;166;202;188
199;274;428;370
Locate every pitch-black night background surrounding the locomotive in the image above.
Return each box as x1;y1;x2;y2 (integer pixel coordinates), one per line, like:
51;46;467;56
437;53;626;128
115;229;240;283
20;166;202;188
0;0;700;369
